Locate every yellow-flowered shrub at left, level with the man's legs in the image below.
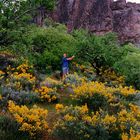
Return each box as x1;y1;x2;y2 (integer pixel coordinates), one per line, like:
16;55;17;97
6;63;36;90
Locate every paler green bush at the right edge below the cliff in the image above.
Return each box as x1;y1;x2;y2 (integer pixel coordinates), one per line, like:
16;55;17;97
114;44;140;89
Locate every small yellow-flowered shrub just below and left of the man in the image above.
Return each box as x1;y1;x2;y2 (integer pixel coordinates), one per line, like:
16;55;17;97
35;86;58;102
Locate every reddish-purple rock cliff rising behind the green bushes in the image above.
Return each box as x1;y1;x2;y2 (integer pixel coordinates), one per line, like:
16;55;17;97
52;0;140;44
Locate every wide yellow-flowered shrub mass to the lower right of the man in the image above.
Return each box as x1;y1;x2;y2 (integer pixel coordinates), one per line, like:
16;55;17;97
72;82;138;113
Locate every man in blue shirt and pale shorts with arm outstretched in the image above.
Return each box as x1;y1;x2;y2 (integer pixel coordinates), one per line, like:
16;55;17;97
62;53;74;80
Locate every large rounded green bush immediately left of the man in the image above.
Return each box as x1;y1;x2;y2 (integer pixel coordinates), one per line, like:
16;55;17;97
32;25;77;70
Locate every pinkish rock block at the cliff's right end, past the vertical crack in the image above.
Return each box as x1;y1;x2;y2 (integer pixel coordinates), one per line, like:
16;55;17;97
112;0;140;44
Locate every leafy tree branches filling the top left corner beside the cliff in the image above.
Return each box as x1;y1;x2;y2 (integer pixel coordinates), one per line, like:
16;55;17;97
0;0;55;25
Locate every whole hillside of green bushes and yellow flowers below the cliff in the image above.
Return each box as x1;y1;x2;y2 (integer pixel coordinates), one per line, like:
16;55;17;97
0;0;140;140
